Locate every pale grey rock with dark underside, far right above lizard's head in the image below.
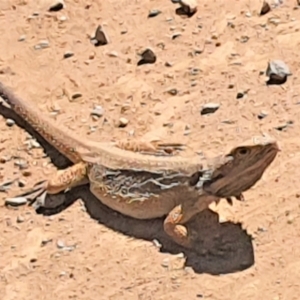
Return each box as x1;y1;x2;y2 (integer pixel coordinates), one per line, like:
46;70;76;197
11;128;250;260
266;60;292;85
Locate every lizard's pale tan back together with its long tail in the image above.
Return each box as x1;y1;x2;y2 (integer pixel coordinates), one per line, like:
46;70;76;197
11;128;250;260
0;82;207;175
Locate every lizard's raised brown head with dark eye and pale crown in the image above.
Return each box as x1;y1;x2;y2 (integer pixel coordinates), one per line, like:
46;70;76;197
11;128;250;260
203;136;280;199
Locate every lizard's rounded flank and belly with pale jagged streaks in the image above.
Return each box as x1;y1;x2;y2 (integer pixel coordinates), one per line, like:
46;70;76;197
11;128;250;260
88;164;197;219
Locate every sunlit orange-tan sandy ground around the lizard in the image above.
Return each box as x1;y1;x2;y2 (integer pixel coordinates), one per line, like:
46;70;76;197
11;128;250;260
0;0;300;300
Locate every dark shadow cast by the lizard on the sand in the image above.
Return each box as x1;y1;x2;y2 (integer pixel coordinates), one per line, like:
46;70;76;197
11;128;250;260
0;104;254;275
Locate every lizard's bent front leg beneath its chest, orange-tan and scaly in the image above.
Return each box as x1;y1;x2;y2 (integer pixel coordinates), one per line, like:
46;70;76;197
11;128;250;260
164;195;219;248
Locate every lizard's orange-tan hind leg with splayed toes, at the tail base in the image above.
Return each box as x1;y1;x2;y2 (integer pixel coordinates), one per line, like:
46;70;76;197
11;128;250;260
13;162;88;206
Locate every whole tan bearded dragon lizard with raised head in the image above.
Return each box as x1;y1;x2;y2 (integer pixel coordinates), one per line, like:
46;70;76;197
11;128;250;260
0;83;279;247
